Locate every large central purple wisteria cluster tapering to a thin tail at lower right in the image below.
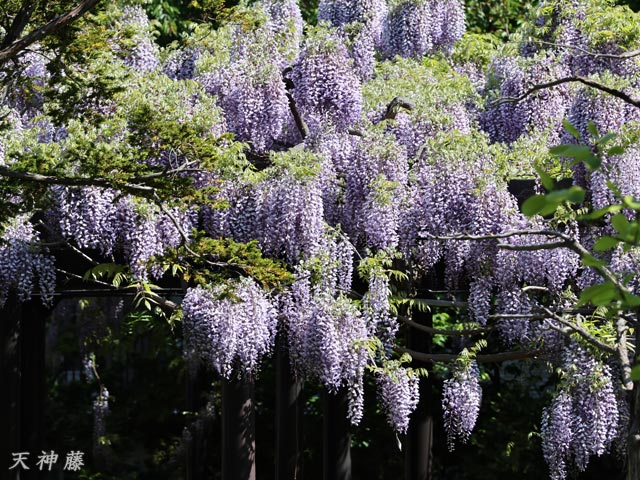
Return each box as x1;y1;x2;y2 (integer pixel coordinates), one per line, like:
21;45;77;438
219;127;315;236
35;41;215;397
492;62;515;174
280;232;371;424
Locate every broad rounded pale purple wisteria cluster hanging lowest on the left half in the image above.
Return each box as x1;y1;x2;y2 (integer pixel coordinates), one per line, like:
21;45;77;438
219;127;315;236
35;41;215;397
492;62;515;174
182;278;278;379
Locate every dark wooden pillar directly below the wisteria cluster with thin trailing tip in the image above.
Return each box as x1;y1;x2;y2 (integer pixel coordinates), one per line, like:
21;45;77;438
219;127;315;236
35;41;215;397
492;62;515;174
322;390;351;480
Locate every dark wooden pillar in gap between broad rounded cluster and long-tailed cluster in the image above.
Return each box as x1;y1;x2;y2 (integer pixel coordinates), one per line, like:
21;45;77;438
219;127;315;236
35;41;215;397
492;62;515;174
275;337;302;480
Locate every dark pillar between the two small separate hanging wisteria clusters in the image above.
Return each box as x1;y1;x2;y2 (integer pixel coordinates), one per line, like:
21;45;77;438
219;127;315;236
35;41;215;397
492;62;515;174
405;298;434;480
